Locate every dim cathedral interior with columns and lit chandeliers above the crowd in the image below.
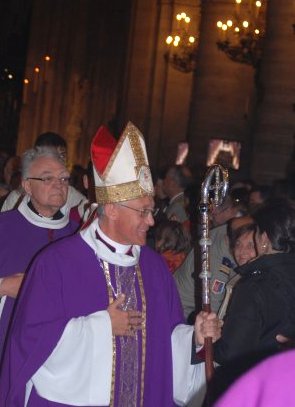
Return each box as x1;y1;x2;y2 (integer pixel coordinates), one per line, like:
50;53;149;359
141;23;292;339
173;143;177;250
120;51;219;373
0;0;295;184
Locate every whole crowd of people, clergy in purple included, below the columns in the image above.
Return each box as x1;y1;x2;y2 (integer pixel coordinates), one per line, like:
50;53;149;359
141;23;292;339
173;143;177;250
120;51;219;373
0;123;295;407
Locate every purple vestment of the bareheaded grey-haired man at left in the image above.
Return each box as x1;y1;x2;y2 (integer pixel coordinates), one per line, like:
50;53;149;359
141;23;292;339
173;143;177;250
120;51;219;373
0;210;78;360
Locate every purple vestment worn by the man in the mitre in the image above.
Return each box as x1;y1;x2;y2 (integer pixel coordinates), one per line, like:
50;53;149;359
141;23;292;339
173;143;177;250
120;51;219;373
0;235;183;407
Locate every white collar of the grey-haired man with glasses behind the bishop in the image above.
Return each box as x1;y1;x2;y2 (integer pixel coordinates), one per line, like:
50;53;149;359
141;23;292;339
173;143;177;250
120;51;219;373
17;195;69;229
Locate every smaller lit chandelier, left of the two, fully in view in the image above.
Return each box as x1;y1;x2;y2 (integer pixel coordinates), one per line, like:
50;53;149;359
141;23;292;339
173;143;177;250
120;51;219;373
165;12;197;73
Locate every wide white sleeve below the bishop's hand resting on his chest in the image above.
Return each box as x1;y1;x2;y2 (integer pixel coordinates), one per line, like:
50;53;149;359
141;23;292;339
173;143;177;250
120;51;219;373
27;311;113;406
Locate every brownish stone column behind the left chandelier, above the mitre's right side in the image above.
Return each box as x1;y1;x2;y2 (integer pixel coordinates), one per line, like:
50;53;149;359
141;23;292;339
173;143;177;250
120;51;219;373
122;0;200;168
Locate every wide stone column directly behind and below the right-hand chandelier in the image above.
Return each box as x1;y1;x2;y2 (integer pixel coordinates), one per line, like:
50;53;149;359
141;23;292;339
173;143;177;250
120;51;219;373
188;0;254;177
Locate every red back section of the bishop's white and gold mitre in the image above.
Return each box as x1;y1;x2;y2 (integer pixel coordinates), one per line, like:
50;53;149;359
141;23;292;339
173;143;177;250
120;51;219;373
90;126;117;175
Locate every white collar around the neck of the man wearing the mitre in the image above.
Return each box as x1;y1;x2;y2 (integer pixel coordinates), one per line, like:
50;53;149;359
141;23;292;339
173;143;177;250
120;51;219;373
80;219;140;267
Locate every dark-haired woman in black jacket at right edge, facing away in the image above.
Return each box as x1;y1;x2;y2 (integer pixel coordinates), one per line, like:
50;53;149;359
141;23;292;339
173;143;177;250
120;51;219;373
208;199;295;404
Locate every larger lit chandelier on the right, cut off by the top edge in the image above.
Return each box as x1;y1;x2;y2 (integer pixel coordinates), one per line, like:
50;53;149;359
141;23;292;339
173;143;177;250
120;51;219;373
217;0;266;68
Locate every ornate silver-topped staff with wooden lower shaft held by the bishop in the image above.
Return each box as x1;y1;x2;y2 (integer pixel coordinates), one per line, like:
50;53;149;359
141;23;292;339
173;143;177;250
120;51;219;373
199;164;228;382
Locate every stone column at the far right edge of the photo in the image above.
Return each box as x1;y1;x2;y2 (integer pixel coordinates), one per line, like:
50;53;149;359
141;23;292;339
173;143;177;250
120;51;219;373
252;0;295;184
